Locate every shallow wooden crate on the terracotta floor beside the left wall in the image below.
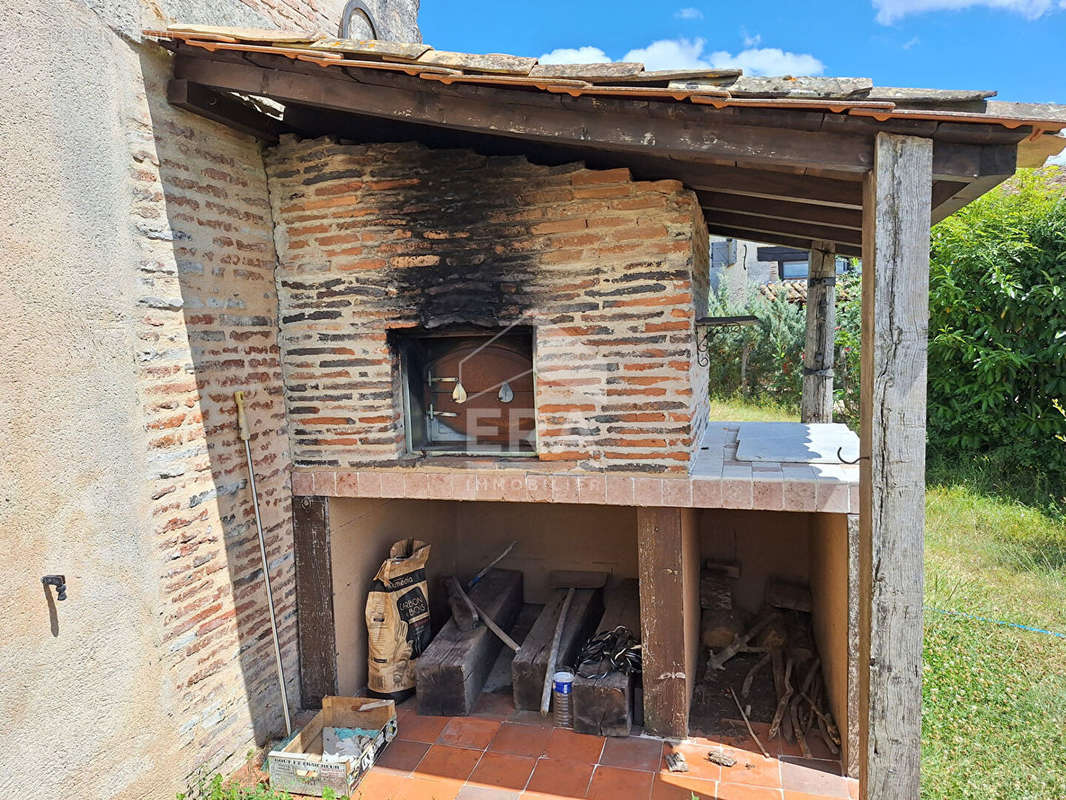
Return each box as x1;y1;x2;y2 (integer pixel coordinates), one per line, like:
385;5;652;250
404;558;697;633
267;697;397;797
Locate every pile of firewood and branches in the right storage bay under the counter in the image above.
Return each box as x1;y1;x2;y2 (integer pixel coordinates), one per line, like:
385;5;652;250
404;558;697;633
700;564;840;757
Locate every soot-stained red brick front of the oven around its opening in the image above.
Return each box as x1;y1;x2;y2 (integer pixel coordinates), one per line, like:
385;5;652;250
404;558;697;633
267;140;708;471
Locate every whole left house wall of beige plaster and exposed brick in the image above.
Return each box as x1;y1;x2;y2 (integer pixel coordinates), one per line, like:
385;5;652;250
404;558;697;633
0;0;418;799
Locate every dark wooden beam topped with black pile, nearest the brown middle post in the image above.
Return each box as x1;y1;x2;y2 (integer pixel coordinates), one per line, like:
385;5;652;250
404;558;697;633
572;579;641;736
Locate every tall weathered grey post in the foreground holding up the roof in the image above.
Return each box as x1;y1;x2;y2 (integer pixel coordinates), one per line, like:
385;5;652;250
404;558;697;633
859;133;933;800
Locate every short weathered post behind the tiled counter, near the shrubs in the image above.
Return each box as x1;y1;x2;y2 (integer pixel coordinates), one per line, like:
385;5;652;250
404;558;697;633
800;242;837;422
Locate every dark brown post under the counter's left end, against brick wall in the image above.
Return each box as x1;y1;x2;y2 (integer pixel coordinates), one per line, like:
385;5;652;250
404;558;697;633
292;497;337;708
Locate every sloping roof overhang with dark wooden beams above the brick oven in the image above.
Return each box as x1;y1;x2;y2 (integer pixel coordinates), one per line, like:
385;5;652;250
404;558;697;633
143;32;1066;255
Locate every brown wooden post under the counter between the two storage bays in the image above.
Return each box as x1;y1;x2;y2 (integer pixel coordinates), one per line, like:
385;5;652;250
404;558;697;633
636;508;699;738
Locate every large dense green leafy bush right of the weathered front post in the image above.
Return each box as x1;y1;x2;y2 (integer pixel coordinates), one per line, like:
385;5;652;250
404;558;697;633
928;173;1066;494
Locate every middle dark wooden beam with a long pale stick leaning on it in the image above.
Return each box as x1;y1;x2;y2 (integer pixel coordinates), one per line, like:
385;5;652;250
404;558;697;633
511;589;603;711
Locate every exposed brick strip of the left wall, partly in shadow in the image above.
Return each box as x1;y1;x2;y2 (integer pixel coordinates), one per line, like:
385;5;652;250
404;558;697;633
131;48;300;771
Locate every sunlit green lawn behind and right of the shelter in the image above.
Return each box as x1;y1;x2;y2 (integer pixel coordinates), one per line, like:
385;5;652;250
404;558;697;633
711;400;1066;800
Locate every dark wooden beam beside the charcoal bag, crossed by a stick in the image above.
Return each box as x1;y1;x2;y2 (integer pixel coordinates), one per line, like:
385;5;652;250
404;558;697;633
416;570;522;716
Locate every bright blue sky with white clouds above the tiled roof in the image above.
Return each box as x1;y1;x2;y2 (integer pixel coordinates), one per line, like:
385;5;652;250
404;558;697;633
419;0;1066;103
